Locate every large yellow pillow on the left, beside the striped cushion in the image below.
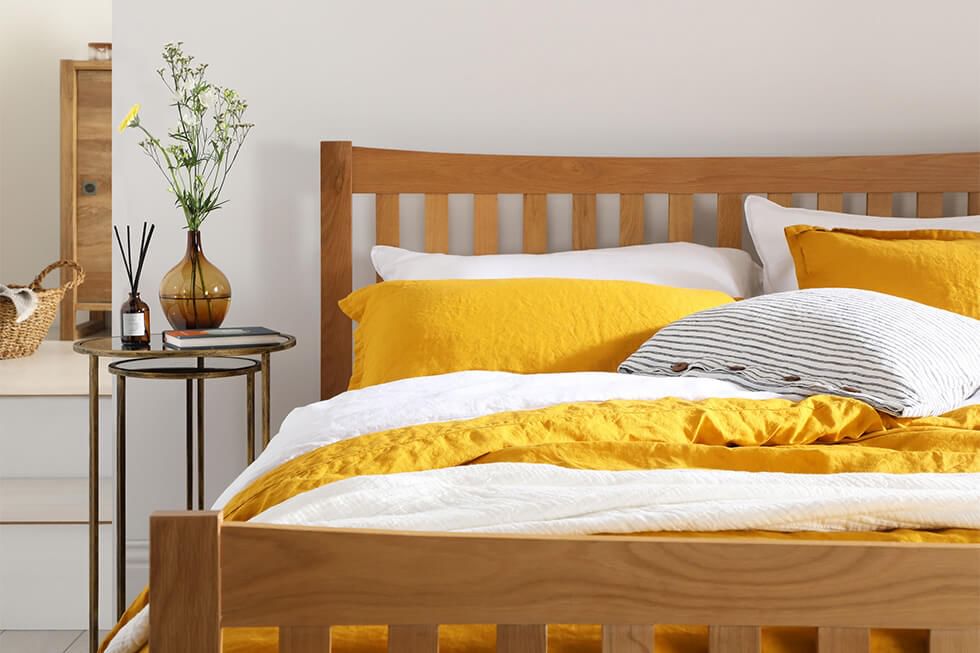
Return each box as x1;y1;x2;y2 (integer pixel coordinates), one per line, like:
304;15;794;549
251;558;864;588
340;279;733;389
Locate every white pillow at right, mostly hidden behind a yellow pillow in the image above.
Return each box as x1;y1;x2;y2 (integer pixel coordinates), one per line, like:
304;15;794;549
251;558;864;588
745;195;980;293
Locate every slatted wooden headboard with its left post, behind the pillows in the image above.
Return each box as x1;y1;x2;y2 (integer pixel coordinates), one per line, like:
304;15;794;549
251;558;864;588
320;141;980;399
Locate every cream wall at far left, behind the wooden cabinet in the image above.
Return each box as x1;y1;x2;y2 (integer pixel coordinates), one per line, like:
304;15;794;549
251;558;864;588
0;0;112;292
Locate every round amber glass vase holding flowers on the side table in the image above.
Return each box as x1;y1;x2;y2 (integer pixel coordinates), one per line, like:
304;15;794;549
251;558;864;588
160;231;231;329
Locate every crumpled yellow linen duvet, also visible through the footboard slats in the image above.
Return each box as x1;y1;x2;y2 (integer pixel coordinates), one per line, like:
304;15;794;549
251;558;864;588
103;373;980;653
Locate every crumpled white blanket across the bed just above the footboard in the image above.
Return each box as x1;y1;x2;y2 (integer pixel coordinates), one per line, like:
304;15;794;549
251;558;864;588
251;463;980;535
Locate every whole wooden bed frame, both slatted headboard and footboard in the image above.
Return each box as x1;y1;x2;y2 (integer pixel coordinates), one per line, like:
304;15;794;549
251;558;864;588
150;142;980;653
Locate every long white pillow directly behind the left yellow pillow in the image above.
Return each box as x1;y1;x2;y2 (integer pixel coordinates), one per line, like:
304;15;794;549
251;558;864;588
371;243;761;297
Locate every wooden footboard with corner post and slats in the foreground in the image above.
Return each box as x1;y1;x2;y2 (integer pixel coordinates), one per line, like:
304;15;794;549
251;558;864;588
150;512;980;653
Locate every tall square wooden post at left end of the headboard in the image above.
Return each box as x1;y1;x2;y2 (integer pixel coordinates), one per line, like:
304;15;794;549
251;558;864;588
320;141;353;399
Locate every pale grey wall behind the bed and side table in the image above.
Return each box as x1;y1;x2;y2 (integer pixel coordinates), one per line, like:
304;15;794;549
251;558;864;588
113;0;980;592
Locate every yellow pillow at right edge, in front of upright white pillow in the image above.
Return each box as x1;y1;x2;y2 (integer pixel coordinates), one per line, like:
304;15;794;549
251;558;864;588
786;225;980;319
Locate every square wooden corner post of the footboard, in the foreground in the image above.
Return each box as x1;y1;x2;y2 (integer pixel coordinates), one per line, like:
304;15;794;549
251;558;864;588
150;512;221;653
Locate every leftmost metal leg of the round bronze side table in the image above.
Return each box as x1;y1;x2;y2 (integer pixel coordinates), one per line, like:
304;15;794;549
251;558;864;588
88;356;99;653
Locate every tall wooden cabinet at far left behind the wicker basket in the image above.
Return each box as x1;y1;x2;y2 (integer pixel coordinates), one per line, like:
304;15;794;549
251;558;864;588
61;60;112;340
